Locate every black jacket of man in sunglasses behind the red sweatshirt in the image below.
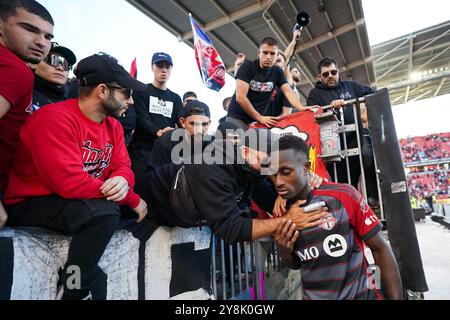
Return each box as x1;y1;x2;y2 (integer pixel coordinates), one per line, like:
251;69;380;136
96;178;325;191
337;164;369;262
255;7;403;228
33;75;67;111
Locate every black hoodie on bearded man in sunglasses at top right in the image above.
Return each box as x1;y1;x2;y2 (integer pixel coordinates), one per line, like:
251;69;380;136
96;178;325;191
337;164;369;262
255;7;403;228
307;80;374;124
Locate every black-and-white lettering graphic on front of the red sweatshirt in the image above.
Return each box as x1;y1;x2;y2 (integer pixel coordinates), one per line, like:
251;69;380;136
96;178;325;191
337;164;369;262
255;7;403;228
82;141;113;179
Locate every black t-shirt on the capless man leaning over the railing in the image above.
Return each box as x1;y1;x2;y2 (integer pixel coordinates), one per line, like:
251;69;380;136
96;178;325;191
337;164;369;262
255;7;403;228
228;60;287;124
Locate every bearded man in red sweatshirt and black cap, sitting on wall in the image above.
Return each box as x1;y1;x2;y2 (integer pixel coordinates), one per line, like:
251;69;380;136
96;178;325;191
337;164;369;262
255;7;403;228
5;54;147;300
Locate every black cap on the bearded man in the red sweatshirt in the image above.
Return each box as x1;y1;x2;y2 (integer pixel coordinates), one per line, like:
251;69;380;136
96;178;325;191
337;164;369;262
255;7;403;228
74;53;147;91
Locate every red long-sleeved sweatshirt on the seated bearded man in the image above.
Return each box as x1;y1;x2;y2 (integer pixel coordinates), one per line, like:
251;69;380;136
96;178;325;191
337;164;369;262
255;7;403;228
4;99;139;208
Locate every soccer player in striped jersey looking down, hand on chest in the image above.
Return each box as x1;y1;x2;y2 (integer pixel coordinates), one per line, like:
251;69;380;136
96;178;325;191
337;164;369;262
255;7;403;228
271;135;402;300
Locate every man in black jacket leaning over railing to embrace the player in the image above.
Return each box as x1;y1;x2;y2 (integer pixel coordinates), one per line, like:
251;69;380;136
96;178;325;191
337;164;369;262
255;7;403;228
136;129;324;244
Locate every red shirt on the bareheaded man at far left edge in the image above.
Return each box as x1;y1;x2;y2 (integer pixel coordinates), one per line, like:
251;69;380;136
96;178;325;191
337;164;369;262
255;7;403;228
0;44;34;192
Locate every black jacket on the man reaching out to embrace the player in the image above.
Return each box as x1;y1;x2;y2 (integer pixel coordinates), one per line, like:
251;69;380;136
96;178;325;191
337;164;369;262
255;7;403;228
135;141;277;243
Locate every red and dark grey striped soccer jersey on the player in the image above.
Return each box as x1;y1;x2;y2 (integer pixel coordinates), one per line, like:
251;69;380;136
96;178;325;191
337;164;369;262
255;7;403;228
293;183;382;300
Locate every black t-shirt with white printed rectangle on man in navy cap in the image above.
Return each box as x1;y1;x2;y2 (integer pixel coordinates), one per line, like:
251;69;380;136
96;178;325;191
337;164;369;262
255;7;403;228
132;84;183;151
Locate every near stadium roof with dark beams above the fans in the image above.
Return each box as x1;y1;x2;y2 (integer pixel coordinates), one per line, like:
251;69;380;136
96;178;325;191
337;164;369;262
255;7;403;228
127;0;375;102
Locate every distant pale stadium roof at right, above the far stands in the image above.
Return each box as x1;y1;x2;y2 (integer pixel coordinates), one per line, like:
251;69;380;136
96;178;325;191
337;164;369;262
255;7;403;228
372;20;450;104
